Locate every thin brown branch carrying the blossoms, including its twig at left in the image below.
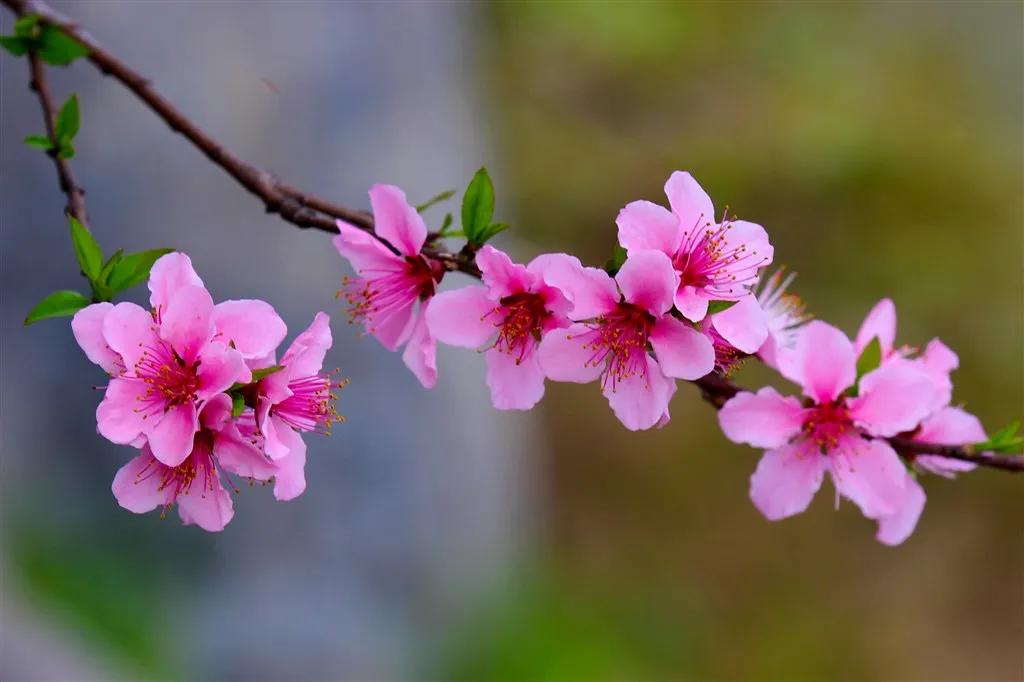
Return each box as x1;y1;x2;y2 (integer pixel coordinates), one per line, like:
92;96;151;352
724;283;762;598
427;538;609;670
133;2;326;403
6;0;1024;472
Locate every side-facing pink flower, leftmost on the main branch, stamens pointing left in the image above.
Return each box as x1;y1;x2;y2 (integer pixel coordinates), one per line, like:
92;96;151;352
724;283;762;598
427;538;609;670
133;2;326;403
334;184;443;388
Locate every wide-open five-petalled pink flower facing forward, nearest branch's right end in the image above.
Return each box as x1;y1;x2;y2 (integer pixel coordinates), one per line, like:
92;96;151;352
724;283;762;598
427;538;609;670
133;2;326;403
719;322;935;541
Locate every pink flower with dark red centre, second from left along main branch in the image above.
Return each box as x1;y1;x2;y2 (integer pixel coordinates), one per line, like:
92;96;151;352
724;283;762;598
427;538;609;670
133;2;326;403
426;246;578;410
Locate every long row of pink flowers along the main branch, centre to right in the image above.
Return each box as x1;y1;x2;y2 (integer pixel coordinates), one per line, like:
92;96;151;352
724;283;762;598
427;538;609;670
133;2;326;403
335;172;985;544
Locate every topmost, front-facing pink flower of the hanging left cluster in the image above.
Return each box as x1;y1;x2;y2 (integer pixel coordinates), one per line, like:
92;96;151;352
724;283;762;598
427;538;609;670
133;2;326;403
72;253;286;467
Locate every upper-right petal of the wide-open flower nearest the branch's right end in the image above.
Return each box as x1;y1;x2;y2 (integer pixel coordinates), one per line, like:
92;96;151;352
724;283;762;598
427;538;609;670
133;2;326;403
849;365;935;437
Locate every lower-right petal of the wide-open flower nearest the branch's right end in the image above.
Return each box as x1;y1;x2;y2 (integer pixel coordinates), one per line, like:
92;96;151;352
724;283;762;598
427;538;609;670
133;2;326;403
828;436;906;519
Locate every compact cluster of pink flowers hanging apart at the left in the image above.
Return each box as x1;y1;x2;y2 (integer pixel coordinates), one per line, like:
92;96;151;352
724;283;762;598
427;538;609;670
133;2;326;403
72;253;340;530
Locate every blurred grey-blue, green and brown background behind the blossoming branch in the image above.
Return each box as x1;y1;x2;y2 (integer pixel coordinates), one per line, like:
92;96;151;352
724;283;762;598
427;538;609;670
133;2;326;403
0;0;1024;680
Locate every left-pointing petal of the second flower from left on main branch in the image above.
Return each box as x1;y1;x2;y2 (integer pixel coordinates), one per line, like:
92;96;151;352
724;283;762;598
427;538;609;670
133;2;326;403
424;287;495;348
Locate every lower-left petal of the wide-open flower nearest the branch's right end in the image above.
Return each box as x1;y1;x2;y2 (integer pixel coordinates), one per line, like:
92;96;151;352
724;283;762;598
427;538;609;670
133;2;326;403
751;444;827;521
